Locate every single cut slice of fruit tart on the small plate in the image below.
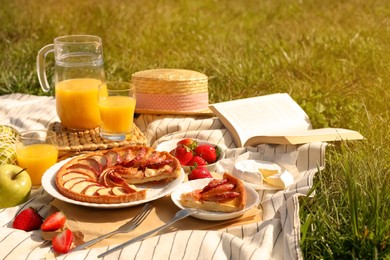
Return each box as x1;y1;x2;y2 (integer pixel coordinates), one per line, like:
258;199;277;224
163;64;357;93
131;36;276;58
180;173;246;212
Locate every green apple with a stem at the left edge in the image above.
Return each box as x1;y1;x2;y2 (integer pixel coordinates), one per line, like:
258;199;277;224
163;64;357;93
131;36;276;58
0;164;31;208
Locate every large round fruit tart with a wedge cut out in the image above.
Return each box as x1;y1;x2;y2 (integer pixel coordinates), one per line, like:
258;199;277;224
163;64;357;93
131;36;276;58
55;146;181;204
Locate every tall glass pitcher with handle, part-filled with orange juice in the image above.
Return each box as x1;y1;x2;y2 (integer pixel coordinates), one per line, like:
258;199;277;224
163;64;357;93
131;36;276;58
37;35;105;130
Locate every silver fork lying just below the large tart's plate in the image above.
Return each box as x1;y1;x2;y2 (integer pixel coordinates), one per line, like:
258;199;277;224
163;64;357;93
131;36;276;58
71;203;153;252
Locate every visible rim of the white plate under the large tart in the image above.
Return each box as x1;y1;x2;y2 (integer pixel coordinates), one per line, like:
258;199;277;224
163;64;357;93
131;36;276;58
42;158;185;208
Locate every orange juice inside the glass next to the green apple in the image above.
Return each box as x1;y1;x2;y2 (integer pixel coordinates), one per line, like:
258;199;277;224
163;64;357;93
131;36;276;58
16;144;58;186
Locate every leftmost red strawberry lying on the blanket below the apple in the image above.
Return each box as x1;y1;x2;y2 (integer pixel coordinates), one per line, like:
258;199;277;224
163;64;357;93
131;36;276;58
12;207;42;231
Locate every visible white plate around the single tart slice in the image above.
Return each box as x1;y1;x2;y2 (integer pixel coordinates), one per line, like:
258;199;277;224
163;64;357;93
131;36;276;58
171;178;259;221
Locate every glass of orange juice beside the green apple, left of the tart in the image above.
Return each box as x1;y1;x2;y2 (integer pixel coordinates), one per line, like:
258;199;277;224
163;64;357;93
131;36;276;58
15;130;58;186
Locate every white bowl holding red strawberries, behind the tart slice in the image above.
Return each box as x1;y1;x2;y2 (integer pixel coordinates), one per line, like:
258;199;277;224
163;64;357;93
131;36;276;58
156;138;225;173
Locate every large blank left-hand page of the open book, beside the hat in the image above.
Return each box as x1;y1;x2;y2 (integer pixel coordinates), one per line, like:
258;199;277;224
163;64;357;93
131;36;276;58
210;93;311;146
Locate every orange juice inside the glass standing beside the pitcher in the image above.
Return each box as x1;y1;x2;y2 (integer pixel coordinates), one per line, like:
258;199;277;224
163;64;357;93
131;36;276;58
99;96;135;133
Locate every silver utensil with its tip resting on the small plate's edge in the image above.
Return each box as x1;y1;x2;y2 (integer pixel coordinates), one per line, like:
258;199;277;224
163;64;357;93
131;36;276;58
98;208;197;258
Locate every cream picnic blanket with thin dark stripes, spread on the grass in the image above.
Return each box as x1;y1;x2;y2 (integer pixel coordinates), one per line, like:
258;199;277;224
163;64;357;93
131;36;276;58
0;93;326;259
